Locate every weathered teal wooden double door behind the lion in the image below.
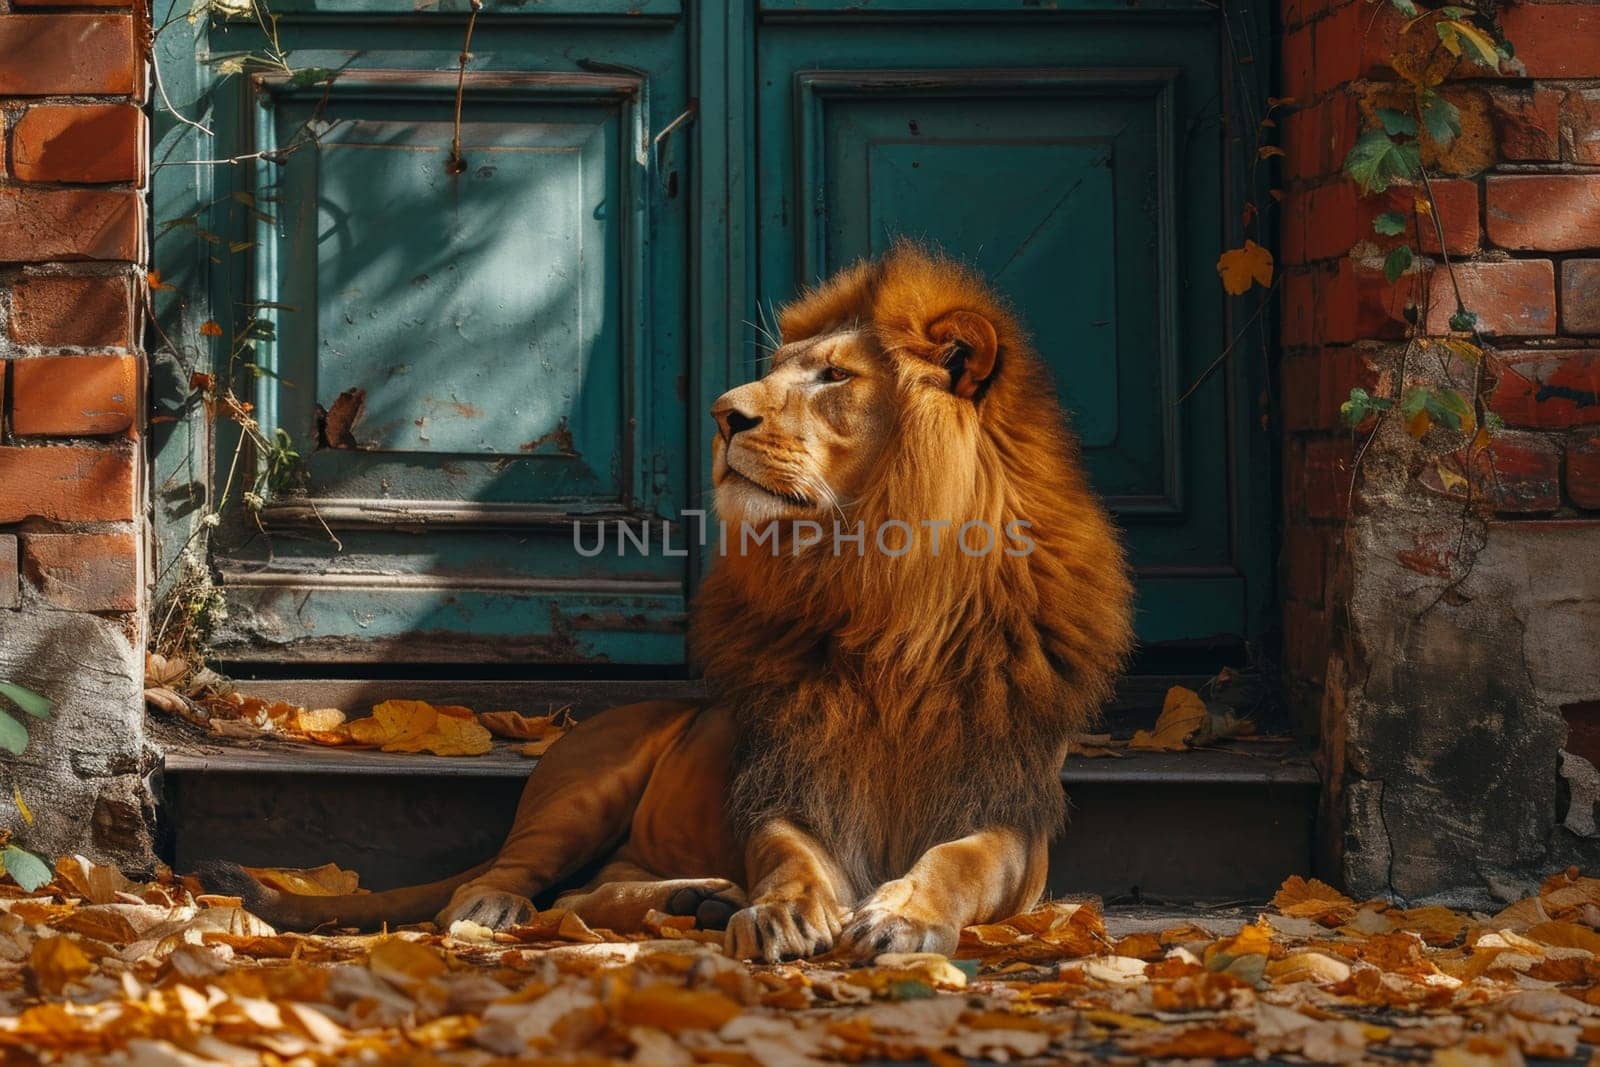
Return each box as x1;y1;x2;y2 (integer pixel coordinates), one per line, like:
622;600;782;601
154;0;1270;669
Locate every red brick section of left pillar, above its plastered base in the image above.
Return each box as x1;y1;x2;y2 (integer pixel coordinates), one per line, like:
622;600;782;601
0;0;149;617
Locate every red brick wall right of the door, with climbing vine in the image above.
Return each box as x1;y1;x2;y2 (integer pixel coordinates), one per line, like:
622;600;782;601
1278;0;1600;723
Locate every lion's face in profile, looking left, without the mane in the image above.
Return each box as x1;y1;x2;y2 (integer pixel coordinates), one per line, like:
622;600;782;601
712;330;898;525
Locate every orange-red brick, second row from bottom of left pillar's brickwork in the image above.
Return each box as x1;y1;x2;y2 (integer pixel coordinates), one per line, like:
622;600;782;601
0;445;134;523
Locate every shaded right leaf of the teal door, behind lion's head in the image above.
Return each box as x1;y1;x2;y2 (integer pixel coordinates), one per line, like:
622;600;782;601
758;12;1267;641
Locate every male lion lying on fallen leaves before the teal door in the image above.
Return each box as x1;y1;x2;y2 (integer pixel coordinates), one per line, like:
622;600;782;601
208;242;1133;961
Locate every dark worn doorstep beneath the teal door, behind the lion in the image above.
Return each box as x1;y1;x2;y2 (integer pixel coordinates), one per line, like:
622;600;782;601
152;678;1318;902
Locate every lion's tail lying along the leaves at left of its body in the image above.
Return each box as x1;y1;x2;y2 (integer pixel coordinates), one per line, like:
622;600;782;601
198;861;493;929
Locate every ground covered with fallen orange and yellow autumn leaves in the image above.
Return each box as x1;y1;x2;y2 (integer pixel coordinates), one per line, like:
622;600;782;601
0;859;1600;1065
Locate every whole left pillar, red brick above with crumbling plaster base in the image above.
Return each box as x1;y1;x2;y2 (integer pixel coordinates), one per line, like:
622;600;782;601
0;0;155;869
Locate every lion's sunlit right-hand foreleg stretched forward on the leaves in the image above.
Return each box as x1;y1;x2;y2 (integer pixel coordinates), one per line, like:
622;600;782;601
840;830;1050;958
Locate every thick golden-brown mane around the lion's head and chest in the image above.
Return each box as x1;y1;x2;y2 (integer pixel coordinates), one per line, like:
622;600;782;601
691;243;1133;886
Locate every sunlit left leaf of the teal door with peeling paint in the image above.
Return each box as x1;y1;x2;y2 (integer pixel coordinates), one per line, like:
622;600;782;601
176;22;690;667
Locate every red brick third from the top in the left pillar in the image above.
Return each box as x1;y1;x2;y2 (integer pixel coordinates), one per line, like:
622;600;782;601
0;186;144;262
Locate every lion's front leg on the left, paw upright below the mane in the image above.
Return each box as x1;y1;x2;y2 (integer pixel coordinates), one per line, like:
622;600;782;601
726;819;848;963
